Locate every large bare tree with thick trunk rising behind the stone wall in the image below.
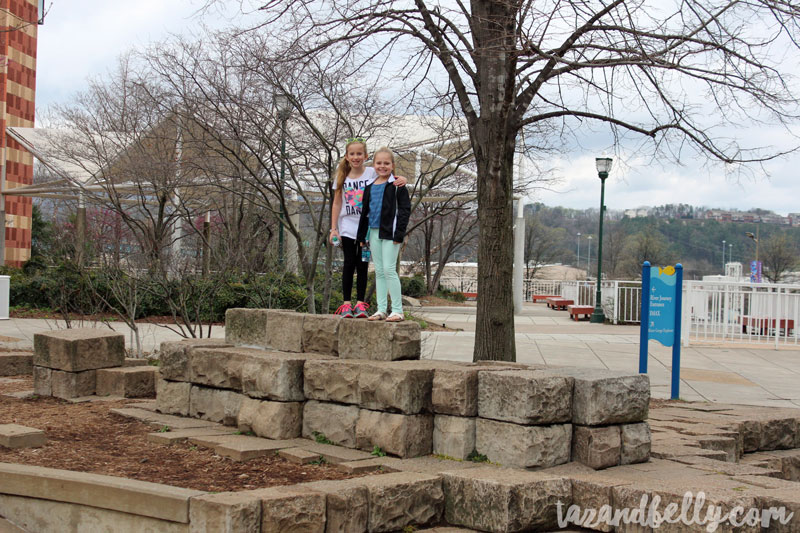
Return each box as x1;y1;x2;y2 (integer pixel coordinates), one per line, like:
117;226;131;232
220;0;800;360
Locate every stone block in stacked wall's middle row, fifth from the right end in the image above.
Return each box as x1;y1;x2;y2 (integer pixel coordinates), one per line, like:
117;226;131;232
303;359;363;405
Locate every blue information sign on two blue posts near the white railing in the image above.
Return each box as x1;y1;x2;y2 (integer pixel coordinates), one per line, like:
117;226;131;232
639;261;683;400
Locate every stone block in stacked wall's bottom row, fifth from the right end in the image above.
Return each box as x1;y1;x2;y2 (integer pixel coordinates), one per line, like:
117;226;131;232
356;409;433;457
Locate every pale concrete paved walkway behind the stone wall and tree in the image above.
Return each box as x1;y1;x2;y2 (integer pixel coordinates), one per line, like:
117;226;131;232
0;304;800;407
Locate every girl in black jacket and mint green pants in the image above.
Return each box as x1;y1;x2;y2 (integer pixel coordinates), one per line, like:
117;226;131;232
358;147;411;322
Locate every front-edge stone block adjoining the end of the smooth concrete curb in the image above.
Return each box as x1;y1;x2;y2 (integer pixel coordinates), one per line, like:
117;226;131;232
189;491;261;533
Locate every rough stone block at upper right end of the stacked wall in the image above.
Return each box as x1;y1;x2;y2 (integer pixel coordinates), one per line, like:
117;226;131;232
552;367;650;426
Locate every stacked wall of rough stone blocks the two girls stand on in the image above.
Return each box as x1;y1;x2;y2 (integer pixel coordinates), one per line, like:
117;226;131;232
157;309;649;468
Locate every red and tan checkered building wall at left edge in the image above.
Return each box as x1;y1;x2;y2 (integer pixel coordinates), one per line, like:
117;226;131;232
0;0;39;266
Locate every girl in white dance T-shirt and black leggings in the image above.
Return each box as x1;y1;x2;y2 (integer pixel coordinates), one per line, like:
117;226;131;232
329;137;407;318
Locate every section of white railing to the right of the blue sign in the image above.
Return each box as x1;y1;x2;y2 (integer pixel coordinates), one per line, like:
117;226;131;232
681;281;800;348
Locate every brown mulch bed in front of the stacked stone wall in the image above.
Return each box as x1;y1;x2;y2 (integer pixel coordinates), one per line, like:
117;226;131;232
0;376;368;492
